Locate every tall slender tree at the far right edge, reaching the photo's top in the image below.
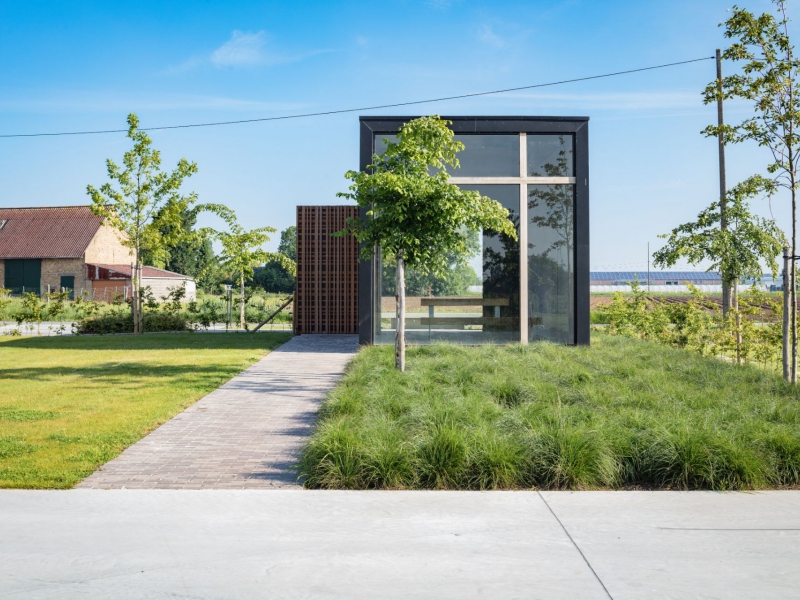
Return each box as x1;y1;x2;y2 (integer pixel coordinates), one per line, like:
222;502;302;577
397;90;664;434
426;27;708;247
704;0;800;382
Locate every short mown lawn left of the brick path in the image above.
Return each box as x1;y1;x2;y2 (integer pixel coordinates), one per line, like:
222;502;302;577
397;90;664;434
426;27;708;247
0;333;290;488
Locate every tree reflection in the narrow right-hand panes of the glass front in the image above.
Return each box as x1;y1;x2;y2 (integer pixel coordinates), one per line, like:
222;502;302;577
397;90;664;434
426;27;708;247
528;136;574;336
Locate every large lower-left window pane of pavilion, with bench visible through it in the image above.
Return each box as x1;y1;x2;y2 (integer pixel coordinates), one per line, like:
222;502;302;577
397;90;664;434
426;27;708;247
374;185;519;344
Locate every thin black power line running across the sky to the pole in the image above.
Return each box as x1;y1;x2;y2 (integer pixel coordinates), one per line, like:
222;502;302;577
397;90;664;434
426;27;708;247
0;56;715;138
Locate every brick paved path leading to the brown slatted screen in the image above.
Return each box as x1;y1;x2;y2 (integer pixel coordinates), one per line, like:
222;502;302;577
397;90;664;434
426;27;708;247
77;335;358;489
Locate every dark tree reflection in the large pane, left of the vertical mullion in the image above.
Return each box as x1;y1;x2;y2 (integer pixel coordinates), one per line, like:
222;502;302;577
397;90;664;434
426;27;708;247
483;210;519;331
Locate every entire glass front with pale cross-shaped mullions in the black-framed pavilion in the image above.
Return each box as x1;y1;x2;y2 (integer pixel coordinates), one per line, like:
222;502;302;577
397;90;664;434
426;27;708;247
374;133;575;344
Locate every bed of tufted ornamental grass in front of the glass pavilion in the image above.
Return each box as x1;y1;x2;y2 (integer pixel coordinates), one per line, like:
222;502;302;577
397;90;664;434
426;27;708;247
301;333;800;490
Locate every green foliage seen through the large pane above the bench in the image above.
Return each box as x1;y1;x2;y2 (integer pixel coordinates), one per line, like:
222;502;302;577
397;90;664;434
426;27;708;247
381;231;481;296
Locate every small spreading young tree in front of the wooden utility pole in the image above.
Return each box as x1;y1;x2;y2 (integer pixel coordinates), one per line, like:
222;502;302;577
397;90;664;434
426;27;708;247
653;175;786;364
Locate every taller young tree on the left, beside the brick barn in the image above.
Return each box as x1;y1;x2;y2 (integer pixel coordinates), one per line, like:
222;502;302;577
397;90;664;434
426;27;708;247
86;113;200;333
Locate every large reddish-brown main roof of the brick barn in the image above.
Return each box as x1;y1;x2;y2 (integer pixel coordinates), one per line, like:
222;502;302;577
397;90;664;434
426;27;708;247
0;206;100;258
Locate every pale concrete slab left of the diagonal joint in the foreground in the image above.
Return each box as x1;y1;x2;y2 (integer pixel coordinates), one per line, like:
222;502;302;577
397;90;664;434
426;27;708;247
0;490;607;600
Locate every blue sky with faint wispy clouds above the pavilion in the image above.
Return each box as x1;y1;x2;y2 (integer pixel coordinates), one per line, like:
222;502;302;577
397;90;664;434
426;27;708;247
0;0;790;270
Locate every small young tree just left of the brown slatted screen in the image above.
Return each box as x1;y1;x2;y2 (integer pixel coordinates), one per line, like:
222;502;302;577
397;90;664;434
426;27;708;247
201;209;295;329
